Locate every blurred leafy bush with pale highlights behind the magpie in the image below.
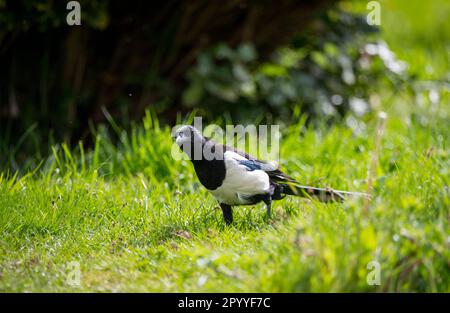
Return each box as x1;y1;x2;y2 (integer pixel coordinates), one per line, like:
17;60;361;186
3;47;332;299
184;10;408;120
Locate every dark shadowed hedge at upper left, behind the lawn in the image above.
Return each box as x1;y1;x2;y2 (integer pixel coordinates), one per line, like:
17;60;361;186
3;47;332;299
0;0;336;154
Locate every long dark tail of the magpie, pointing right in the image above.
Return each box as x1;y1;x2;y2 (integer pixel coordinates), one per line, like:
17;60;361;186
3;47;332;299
279;183;369;202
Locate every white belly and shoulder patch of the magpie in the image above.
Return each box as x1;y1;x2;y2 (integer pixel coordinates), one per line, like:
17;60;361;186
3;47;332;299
210;151;270;205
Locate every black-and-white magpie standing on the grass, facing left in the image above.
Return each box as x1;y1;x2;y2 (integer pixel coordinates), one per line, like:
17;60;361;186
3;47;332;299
173;125;367;225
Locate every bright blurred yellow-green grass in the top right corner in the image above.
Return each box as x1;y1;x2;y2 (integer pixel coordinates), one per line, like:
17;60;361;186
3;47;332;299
350;0;450;81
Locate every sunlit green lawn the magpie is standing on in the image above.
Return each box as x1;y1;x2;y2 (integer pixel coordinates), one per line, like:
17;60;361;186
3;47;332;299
0;88;450;292
